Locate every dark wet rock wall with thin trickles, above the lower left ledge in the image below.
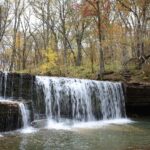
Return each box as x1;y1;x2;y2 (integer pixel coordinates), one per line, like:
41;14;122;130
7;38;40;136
0;72;35;100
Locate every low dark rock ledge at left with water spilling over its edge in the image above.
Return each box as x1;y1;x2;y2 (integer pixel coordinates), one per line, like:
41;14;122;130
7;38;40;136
0;97;30;131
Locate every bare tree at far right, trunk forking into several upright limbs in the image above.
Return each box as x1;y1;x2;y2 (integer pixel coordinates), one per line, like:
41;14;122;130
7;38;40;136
117;0;150;65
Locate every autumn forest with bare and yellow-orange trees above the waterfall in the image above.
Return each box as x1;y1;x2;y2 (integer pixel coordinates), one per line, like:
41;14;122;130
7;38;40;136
0;0;150;81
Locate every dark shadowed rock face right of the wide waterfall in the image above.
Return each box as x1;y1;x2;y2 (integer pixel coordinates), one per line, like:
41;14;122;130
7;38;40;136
124;83;150;117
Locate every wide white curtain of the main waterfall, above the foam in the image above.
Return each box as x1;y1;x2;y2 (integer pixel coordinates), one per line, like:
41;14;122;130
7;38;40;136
36;76;126;121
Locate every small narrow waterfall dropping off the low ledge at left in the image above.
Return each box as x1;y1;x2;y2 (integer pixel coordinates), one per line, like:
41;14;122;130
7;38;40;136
18;102;29;128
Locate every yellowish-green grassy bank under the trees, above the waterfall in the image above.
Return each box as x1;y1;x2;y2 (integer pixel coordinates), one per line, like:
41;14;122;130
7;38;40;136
17;62;150;82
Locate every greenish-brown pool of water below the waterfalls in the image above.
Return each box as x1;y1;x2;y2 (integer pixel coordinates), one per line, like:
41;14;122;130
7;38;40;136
0;119;150;150
